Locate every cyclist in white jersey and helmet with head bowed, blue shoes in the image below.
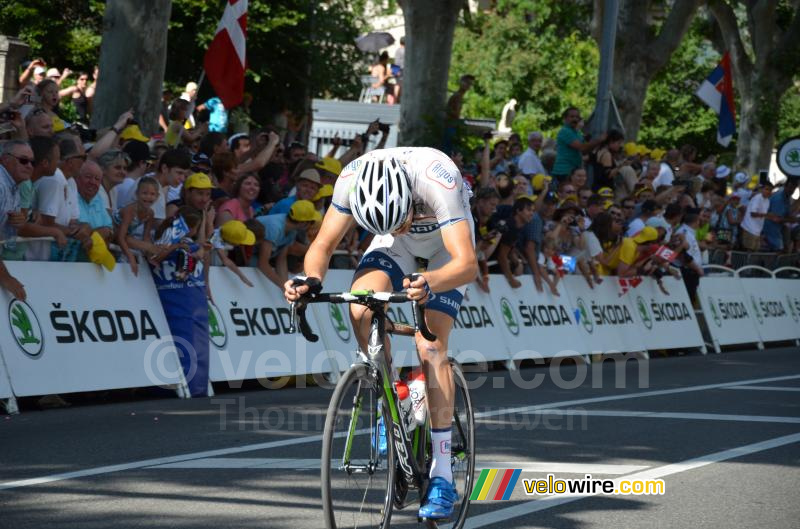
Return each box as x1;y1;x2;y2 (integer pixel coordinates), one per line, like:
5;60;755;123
284;147;478;519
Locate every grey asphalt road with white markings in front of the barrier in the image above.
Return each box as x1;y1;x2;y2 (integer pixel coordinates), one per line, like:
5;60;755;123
0;348;800;529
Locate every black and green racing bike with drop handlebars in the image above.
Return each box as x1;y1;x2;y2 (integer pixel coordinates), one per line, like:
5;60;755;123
290;283;475;529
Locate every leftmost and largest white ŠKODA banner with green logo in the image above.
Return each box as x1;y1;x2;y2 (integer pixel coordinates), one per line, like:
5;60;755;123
0;262;182;397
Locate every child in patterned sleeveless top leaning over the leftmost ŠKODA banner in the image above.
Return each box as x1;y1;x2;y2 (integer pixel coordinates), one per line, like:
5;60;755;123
113;176;160;275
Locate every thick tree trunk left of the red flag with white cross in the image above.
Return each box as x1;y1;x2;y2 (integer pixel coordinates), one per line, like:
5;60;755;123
92;0;172;134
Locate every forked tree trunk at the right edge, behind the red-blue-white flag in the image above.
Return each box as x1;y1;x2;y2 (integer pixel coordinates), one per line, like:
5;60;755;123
708;0;800;174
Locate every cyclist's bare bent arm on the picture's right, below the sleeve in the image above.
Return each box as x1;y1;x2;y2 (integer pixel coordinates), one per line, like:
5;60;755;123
422;220;478;292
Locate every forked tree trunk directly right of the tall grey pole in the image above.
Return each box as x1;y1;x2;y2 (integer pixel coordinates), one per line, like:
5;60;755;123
591;0;700;141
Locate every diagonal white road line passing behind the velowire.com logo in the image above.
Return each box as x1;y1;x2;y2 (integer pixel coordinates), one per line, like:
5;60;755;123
464;433;800;529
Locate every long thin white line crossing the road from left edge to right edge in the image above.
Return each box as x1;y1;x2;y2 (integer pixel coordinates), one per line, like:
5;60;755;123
0;375;800;490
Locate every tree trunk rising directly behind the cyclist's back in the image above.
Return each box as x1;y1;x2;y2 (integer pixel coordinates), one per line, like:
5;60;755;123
399;0;463;147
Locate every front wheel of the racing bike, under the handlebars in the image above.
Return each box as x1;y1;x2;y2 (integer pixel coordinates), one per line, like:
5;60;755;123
321;364;395;529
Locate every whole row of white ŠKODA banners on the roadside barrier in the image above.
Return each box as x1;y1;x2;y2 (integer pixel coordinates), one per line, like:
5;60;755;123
0;262;800;412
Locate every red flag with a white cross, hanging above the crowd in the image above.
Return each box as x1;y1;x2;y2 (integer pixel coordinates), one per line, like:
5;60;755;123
203;0;247;109
